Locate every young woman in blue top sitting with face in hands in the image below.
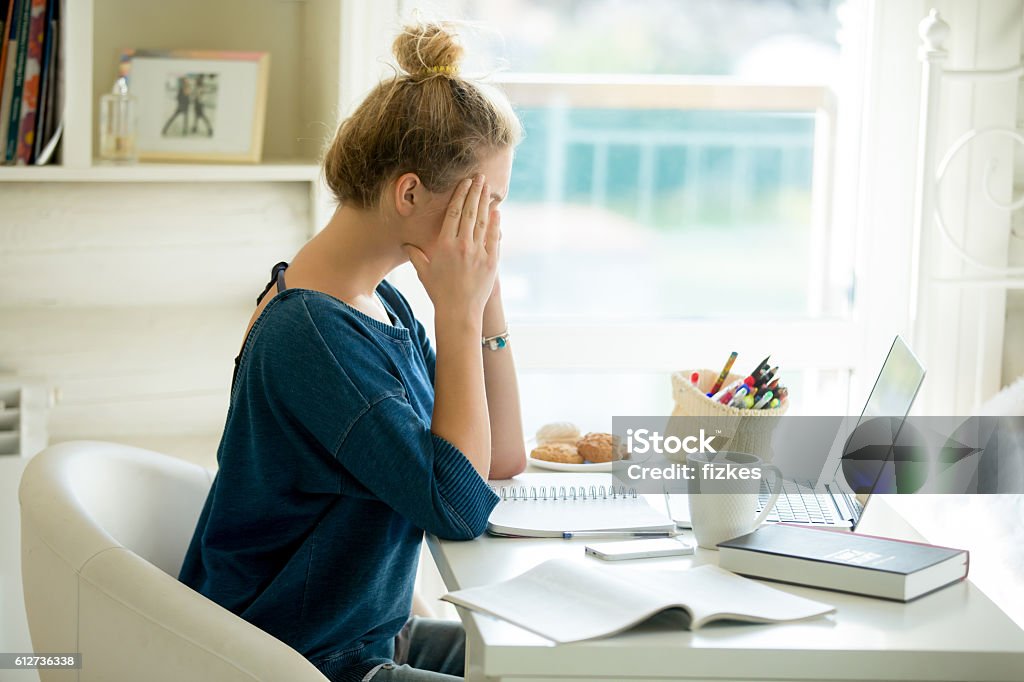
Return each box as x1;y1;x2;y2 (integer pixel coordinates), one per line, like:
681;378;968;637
180;25;525;682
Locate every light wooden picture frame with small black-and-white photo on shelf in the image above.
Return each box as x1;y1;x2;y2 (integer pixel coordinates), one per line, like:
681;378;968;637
119;48;270;163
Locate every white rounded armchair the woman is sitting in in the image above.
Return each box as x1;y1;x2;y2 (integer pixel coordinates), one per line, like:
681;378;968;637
18;441;327;682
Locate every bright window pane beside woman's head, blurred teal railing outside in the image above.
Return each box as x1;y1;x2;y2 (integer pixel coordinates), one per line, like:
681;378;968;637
491;85;843;318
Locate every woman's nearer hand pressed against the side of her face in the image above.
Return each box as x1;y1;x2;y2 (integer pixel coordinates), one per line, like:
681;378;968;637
402;169;501;319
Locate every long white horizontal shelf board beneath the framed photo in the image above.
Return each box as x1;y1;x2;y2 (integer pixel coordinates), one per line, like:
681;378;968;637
0;161;319;182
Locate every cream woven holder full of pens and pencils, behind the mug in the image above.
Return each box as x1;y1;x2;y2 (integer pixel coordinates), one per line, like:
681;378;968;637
672;369;790;462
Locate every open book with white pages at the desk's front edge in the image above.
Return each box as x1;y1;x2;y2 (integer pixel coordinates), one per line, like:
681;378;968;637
441;559;836;644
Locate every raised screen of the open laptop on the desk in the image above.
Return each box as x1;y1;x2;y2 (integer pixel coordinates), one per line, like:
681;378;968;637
826;336;925;527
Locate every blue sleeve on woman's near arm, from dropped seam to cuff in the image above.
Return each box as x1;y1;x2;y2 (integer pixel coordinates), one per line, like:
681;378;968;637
335;395;498;540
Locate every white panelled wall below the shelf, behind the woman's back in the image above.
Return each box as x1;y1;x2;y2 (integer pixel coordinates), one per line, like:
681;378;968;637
0;182;311;459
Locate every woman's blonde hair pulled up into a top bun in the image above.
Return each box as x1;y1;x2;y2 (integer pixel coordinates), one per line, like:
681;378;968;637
323;20;522;209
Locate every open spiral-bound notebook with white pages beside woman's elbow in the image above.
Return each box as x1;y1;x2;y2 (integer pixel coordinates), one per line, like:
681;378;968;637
487;473;676;538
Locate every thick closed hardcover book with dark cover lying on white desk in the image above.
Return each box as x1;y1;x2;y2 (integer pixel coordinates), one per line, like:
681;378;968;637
718;523;970;601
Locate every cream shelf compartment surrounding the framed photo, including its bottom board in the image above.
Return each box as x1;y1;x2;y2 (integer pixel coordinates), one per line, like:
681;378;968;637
40;0;348;169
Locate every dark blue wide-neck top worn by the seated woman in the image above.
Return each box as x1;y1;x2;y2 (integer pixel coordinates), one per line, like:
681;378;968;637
179;282;498;680
